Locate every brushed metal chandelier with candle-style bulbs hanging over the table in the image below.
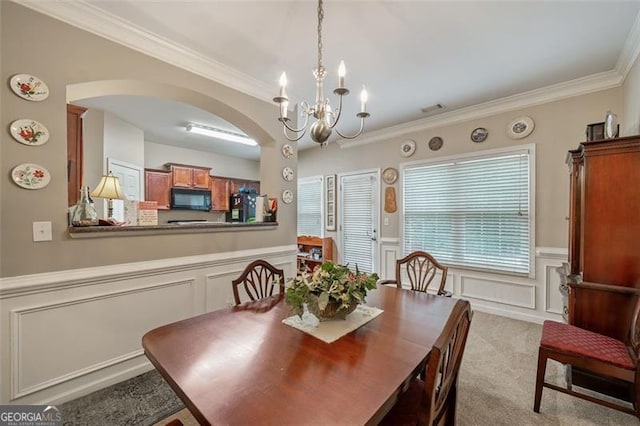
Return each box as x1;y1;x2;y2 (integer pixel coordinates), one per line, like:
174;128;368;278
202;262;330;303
273;0;370;145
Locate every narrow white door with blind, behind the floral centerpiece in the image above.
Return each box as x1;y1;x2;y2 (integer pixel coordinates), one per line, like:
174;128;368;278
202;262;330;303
338;171;380;273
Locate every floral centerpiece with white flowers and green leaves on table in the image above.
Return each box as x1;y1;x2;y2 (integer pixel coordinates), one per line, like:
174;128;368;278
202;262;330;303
285;262;378;321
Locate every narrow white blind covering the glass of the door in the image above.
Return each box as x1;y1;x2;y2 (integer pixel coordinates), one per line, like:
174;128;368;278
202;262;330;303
340;174;375;273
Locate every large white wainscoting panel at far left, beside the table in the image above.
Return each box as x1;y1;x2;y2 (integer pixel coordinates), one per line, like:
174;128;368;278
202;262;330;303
11;279;194;399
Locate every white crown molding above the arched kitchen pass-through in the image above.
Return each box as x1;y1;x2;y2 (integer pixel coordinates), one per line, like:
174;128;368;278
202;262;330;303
12;0;274;103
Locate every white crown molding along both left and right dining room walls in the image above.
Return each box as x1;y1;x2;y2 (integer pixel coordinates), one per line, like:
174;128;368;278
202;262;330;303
12;0;640;148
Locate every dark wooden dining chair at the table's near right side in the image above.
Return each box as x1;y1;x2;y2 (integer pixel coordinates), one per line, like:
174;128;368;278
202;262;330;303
380;299;472;426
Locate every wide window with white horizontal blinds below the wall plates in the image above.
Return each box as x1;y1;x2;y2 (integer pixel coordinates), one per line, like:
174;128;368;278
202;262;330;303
402;145;534;276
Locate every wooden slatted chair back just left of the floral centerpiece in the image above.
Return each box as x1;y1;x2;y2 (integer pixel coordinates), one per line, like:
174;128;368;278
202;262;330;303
231;259;284;305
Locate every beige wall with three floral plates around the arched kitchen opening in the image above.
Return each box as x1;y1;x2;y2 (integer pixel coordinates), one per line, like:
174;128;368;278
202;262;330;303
0;1;296;277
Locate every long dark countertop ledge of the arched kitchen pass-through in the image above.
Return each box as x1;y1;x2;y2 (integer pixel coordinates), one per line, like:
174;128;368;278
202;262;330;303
69;222;278;238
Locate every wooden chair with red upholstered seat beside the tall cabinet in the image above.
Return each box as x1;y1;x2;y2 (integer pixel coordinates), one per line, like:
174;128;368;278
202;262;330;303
533;282;640;419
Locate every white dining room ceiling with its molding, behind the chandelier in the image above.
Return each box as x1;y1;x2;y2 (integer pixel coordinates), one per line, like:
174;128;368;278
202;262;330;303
20;0;640;158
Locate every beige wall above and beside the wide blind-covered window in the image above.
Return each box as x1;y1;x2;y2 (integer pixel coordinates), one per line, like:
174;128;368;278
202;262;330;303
298;89;622;251
